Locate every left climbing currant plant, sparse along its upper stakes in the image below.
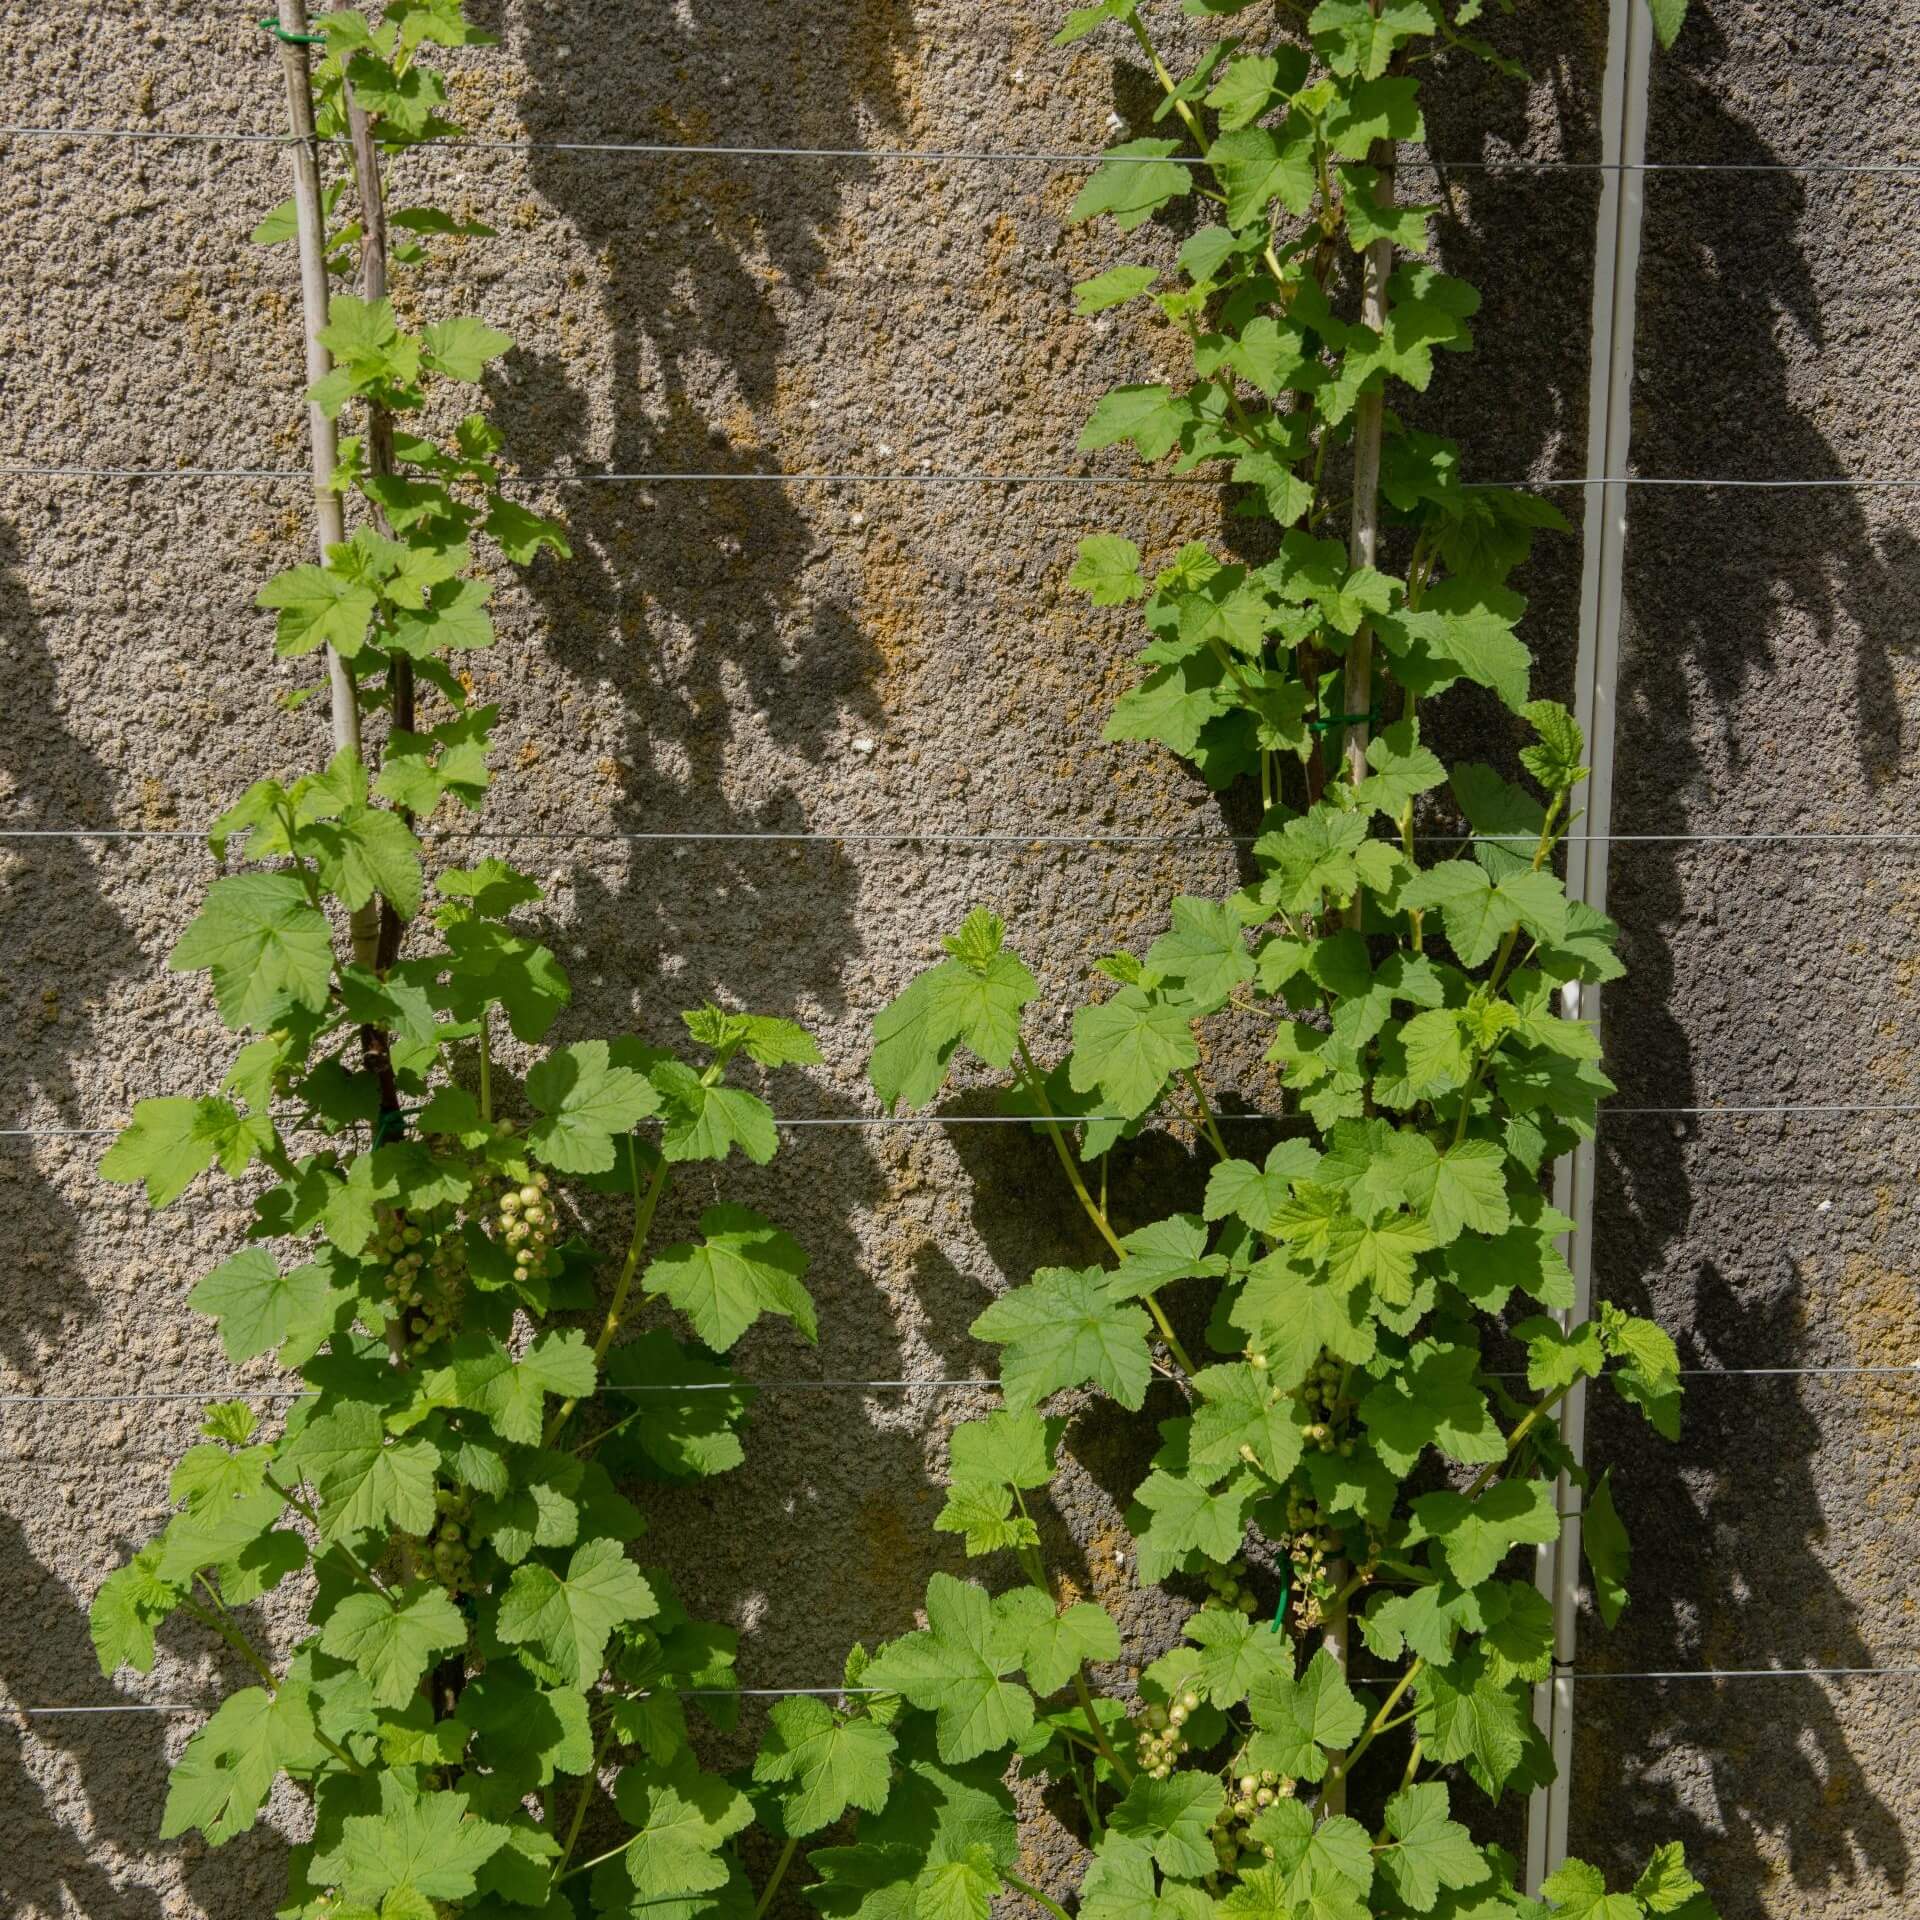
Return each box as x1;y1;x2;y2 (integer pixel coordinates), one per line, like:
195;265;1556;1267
92;0;840;1920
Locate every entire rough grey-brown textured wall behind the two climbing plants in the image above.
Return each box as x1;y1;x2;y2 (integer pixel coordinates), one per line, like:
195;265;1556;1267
0;0;1920;1920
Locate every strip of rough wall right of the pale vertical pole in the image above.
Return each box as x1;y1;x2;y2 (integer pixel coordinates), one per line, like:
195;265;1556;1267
1572;0;1920;1920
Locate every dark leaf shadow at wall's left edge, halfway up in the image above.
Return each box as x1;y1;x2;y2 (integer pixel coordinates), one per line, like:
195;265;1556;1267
0;520;140;1380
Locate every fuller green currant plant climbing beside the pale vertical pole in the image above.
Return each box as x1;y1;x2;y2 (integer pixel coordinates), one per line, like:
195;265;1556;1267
812;11;1711;1920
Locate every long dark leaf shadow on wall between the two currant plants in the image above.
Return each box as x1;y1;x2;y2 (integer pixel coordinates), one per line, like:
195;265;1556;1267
466;0;975;1735
